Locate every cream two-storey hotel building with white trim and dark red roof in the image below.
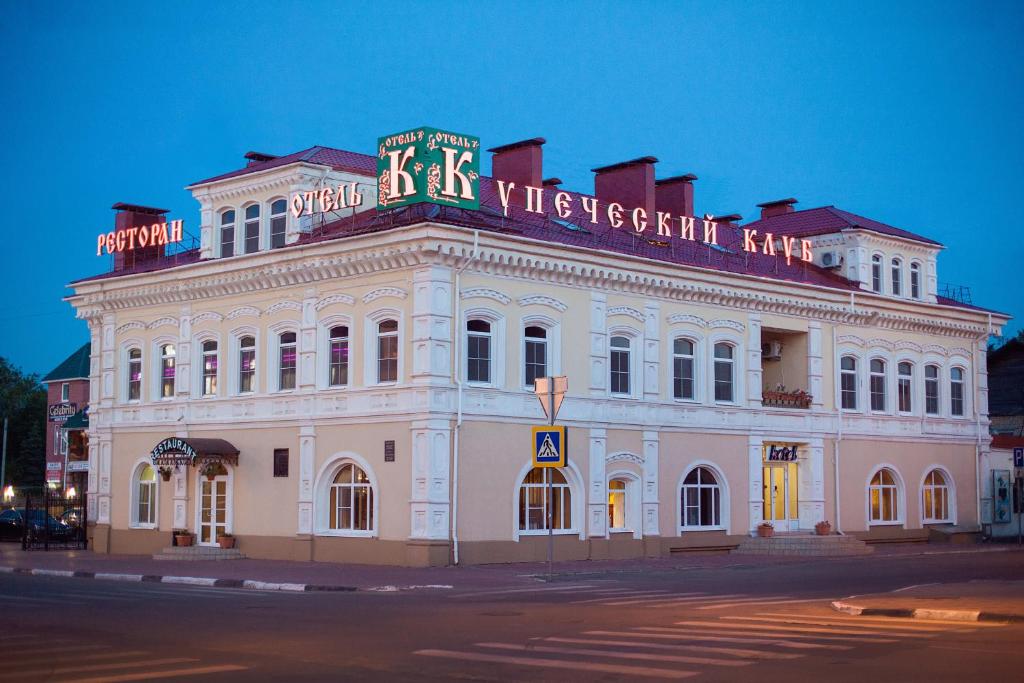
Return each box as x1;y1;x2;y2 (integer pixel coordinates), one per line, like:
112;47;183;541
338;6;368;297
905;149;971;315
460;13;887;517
69;134;1007;565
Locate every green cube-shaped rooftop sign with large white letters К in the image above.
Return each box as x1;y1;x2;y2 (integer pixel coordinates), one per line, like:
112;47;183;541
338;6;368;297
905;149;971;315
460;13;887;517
377;127;480;210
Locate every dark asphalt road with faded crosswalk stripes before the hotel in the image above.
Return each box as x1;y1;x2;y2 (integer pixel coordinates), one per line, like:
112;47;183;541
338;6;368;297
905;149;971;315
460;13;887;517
0;551;1024;683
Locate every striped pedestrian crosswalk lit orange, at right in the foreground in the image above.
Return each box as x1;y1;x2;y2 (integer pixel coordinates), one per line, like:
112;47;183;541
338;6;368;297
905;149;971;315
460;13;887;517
415;610;1001;680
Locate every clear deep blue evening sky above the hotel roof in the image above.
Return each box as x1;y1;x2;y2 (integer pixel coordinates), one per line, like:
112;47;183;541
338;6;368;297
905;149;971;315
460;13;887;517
0;1;1024;373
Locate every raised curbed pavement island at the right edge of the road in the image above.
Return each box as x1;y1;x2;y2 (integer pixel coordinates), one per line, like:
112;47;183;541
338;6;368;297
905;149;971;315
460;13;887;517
831;581;1024;623
